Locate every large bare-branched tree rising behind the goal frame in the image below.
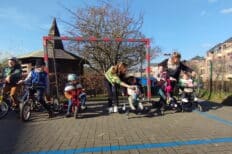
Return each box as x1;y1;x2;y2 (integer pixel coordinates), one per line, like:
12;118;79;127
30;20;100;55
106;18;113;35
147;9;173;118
60;2;159;74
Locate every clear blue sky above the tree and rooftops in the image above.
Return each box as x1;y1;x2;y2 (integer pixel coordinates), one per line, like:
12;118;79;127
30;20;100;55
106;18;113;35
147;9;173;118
0;0;232;61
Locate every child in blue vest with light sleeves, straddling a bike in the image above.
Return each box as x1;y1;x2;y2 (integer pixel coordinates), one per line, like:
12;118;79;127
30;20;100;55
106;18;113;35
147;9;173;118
18;59;53;118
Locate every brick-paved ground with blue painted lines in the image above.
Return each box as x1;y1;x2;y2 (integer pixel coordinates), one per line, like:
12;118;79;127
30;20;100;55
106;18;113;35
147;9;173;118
0;99;232;154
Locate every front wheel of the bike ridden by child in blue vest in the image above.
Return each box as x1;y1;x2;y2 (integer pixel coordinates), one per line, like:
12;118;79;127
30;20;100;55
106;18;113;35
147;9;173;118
19;100;33;121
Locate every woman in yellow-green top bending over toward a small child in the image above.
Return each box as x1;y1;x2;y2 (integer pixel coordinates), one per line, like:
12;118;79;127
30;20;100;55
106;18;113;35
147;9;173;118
105;62;135;113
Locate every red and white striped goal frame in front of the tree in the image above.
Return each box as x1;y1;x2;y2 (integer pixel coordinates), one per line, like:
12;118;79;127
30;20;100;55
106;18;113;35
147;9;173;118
43;36;151;101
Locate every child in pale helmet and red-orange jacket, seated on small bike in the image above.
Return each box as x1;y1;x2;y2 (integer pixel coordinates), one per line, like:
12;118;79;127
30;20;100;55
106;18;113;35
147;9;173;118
64;74;82;117
